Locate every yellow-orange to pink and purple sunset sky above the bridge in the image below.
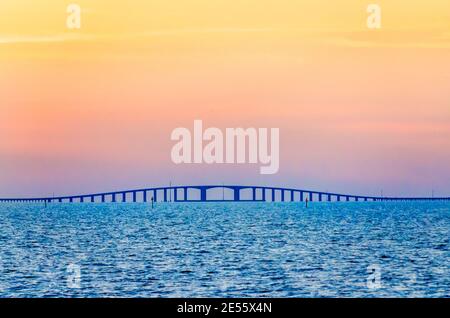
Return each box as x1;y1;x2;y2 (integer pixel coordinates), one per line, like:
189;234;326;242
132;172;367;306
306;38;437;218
0;0;450;197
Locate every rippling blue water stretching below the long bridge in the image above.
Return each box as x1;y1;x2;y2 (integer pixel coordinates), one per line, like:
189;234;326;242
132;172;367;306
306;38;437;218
0;202;450;297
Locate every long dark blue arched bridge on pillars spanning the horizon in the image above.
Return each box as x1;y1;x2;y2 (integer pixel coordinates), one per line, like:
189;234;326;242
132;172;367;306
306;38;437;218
0;185;450;203
